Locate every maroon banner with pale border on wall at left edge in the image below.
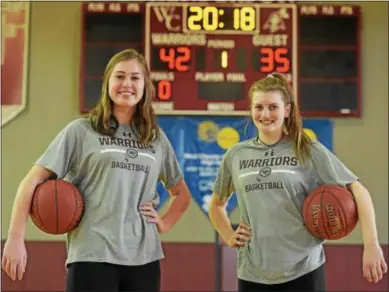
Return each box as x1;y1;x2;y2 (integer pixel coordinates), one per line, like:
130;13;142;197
1;1;30;127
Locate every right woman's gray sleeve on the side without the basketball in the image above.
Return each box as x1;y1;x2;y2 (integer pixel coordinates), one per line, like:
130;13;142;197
213;151;235;201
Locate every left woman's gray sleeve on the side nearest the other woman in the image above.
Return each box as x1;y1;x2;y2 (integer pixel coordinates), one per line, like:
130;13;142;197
159;130;184;189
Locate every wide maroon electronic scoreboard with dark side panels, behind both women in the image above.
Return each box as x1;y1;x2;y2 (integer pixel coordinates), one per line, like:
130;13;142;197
80;1;361;117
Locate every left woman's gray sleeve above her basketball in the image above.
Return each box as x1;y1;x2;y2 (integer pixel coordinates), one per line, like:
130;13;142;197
36;120;83;179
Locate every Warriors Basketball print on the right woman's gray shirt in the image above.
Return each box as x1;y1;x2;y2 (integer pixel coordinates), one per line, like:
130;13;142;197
238;156;298;193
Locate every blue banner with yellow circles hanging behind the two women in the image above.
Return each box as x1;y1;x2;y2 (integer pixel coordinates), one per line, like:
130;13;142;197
157;116;332;217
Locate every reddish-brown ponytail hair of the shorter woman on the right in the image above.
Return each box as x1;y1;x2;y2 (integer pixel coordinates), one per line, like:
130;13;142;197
249;73;312;164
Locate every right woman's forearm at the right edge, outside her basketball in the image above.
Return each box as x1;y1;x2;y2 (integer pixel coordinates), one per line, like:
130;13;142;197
350;182;378;246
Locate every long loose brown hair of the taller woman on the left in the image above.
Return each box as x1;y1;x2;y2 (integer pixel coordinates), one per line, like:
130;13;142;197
89;49;159;144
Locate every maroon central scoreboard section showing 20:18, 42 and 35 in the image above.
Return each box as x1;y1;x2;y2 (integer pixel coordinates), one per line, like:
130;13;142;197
145;3;297;115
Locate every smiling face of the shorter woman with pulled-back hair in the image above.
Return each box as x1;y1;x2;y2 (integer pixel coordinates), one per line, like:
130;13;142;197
251;90;290;137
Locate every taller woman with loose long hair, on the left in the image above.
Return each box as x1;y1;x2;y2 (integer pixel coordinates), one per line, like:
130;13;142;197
2;49;190;292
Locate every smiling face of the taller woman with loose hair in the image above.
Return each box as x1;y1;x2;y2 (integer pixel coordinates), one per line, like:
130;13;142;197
108;59;145;108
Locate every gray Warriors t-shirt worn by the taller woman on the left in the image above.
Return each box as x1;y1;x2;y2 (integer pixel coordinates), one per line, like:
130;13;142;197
37;118;183;265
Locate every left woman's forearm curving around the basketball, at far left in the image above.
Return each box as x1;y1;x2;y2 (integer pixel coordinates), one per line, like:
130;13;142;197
8;166;52;238
